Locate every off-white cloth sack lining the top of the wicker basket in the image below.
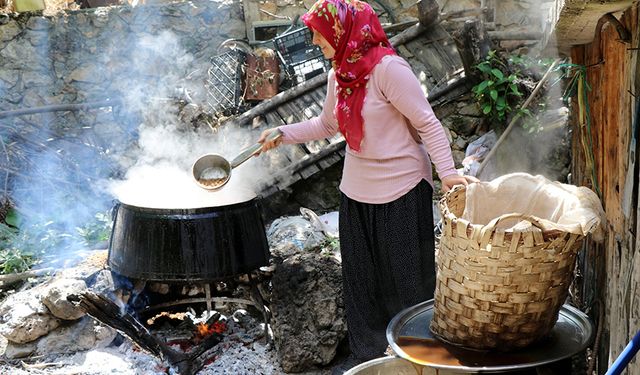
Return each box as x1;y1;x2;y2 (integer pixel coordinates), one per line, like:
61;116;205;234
461;173;606;241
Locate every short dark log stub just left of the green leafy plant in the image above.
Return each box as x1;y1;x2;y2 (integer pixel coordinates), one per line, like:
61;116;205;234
453;20;491;84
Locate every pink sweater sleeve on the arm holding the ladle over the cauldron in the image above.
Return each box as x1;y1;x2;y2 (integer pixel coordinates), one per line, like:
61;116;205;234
278;69;338;144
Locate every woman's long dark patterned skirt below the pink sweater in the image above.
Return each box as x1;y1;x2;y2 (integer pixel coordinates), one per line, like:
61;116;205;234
339;180;435;360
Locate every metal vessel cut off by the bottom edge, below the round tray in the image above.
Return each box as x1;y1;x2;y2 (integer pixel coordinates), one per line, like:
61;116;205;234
344;357;468;375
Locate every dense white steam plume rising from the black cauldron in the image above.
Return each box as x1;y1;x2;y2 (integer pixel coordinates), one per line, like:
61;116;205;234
108;31;266;208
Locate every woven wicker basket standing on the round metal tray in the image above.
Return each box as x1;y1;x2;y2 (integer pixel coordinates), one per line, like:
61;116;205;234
430;186;584;351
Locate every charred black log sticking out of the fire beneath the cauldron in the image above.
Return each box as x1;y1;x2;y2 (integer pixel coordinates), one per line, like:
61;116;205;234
67;292;226;375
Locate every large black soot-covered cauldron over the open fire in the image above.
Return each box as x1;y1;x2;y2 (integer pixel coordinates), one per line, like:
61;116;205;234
109;198;269;282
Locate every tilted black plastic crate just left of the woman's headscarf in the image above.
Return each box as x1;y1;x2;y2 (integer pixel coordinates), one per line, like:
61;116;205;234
273;27;331;83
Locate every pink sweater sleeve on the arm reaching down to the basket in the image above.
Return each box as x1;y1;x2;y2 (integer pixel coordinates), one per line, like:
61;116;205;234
378;58;457;178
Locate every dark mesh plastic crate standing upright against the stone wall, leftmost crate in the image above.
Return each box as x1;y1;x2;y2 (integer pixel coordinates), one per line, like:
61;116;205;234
205;50;247;115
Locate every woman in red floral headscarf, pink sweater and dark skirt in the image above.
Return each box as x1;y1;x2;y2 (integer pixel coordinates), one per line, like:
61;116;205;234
258;0;476;373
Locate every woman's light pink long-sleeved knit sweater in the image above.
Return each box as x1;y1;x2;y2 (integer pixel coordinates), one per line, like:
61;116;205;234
280;56;457;204
